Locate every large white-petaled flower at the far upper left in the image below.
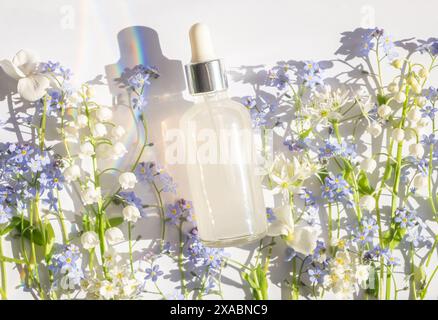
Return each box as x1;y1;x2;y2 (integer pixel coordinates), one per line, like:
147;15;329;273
0;50;50;101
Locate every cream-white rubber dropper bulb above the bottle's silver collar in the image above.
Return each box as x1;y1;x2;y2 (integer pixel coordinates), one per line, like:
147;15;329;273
189;23;216;63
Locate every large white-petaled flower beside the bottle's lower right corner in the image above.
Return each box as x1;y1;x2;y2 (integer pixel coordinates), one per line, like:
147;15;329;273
268;205;320;256
